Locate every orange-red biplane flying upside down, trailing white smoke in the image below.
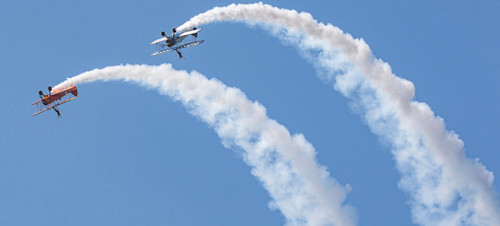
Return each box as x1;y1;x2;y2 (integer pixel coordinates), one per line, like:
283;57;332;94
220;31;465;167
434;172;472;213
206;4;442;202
31;86;78;117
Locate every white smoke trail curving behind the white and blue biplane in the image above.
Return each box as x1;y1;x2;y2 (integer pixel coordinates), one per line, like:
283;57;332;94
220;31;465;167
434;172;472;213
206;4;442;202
178;3;500;225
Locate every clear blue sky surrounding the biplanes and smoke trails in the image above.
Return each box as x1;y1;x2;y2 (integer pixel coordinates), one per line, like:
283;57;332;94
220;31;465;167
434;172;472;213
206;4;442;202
0;1;500;225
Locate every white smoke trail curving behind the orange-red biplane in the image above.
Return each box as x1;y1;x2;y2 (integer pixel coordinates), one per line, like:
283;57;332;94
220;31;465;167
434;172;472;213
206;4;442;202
54;64;356;225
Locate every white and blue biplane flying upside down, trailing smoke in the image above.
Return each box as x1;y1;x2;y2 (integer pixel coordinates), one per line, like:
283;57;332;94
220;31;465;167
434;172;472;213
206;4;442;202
151;27;204;59
